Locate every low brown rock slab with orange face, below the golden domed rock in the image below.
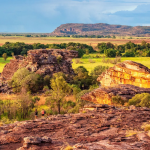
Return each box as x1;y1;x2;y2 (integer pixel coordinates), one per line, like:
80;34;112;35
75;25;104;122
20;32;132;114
81;84;150;104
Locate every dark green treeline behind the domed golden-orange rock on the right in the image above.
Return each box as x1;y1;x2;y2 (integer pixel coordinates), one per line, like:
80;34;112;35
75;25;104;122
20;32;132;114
97;41;150;57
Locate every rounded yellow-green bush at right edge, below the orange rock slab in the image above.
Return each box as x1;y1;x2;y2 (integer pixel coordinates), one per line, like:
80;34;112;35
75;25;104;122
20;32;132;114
128;93;150;108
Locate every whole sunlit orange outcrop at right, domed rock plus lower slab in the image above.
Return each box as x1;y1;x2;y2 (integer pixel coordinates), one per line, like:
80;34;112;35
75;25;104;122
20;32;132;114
82;61;150;104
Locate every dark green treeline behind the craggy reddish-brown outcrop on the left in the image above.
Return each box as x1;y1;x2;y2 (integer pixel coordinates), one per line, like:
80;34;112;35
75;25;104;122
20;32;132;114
0;42;95;57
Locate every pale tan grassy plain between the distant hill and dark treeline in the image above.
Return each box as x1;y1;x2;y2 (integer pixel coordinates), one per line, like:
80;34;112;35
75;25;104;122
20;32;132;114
0;36;150;47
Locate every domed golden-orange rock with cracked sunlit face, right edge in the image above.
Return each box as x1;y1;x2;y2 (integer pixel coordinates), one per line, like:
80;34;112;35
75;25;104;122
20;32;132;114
97;60;150;88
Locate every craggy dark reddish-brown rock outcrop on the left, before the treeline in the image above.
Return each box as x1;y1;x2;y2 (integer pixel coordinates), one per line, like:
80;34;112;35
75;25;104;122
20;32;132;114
1;49;78;81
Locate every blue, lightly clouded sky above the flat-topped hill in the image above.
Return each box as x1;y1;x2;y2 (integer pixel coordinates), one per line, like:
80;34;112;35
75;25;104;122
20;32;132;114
0;0;150;33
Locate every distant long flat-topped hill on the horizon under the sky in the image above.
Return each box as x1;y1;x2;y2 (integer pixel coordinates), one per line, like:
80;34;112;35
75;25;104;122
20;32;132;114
50;23;150;36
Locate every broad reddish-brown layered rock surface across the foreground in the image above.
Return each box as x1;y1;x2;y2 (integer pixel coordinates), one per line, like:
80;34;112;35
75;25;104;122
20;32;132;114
0;105;150;150
